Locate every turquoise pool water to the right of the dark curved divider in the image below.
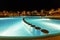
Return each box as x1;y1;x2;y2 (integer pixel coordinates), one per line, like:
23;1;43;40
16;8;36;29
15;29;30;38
26;18;60;35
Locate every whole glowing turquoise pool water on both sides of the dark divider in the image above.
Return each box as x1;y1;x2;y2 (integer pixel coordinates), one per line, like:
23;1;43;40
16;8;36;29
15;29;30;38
0;17;60;36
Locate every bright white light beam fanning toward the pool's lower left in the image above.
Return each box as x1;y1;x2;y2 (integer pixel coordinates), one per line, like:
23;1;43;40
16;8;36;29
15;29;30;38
0;23;23;36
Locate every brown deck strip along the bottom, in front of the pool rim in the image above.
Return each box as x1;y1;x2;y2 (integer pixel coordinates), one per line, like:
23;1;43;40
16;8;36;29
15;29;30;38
0;35;60;40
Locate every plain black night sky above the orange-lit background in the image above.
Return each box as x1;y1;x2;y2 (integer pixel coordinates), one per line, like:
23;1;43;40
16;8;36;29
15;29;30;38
0;0;60;11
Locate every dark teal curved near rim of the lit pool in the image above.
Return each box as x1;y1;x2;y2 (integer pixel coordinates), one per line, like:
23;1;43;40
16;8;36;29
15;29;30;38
0;33;60;39
